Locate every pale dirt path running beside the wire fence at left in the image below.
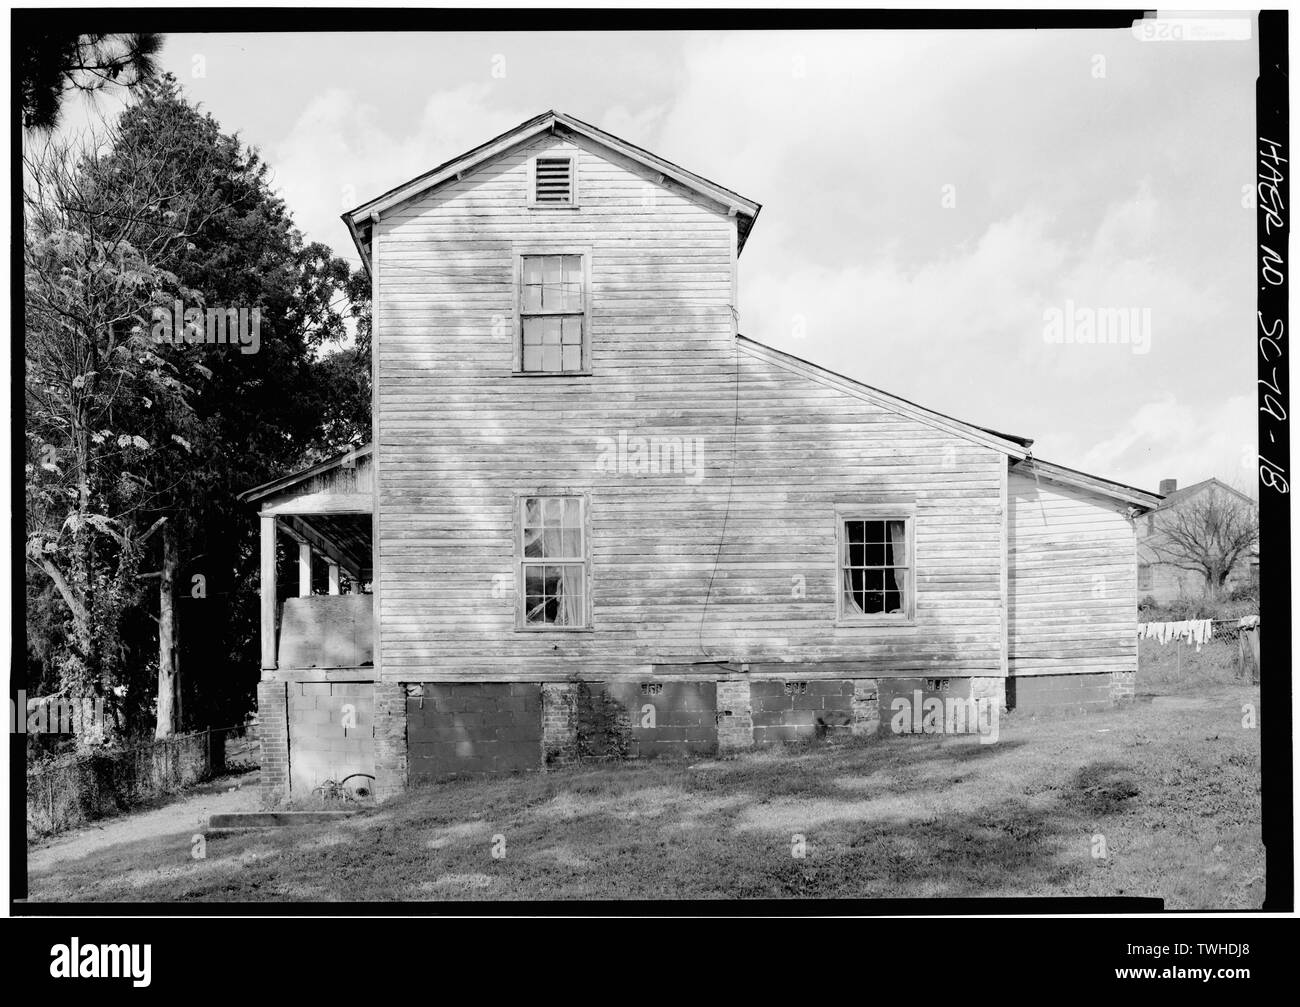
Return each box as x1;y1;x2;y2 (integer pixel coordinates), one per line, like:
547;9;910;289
27;771;257;887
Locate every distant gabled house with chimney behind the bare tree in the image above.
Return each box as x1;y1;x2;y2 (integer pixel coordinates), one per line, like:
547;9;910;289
1138;478;1260;604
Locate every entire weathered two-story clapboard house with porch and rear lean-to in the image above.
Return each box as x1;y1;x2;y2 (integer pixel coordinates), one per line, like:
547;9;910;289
243;112;1158;794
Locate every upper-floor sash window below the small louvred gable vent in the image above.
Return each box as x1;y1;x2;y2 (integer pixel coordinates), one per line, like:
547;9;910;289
515;252;589;374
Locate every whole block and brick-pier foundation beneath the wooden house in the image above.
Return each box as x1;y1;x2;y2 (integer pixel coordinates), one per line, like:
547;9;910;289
257;673;1134;799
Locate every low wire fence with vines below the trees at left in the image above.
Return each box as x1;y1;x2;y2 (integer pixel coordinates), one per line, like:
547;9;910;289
27;724;259;835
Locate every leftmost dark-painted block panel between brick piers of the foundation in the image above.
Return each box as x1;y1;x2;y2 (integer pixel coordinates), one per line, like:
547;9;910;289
406;682;542;782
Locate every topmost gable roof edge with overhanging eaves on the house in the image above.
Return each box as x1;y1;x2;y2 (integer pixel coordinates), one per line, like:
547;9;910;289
343;109;762;272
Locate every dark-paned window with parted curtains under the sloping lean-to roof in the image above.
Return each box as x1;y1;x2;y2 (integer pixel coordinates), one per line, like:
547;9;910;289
837;509;915;625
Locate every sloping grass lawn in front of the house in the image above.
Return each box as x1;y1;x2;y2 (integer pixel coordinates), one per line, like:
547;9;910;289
30;648;1264;910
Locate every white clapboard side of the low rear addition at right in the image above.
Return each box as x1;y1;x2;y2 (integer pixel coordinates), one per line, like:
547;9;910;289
1008;473;1138;674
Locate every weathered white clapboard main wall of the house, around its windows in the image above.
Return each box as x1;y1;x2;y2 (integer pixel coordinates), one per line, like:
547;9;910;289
376;136;1006;681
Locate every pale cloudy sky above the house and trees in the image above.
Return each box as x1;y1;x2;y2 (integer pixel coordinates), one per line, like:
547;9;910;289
142;30;1257;489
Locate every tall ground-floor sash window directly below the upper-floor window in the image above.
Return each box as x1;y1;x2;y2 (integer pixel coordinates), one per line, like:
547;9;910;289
517;496;589;629
